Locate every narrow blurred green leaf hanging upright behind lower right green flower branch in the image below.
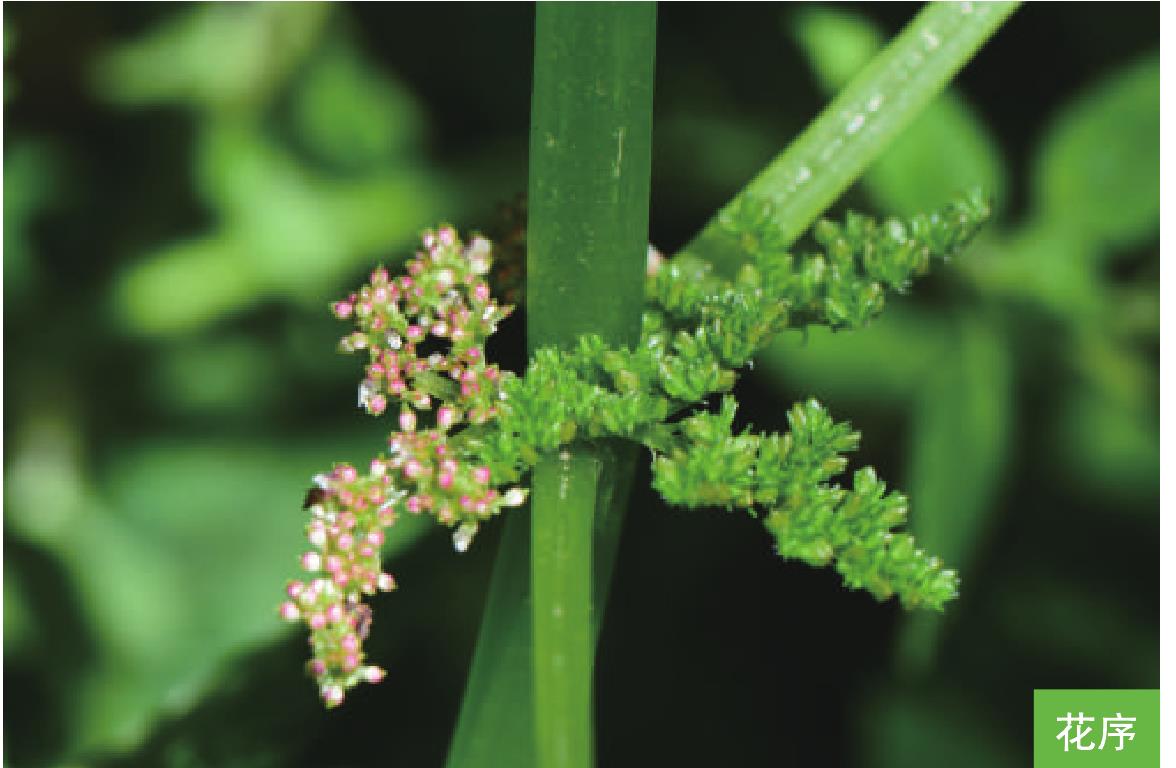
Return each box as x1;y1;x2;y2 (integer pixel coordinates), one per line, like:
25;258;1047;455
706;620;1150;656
898;314;1013;673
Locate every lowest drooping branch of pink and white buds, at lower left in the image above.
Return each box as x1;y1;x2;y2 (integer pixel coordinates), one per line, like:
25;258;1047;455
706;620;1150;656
279;461;405;707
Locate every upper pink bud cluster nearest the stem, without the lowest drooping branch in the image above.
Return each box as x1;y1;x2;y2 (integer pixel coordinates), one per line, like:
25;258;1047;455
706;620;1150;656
335;226;523;538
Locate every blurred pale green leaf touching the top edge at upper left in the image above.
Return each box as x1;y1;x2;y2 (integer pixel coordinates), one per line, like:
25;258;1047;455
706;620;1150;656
94;2;330;109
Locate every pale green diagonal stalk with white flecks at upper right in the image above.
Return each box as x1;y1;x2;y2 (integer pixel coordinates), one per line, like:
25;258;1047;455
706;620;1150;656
683;2;1018;266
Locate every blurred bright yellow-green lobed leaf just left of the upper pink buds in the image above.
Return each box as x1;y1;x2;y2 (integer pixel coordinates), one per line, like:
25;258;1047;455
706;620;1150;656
114;119;441;334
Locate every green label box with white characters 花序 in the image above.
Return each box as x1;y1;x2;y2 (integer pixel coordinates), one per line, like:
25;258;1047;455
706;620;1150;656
1033;689;1160;768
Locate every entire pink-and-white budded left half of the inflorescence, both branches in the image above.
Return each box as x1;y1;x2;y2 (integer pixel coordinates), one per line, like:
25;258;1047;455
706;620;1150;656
280;226;526;707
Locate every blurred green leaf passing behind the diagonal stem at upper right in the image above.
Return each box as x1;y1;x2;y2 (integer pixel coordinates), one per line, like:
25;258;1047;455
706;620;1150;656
794;6;1007;215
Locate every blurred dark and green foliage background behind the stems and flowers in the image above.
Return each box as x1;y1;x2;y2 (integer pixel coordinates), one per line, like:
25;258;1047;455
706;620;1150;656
4;4;1160;768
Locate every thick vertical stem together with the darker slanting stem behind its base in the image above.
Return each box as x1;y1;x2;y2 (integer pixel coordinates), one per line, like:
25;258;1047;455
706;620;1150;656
448;2;655;768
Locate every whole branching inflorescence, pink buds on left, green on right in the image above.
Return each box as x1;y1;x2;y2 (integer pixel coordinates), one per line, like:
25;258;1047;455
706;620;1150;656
281;194;989;706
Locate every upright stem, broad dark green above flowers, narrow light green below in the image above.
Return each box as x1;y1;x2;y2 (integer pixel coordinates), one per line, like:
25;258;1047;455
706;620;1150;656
527;2;655;768
